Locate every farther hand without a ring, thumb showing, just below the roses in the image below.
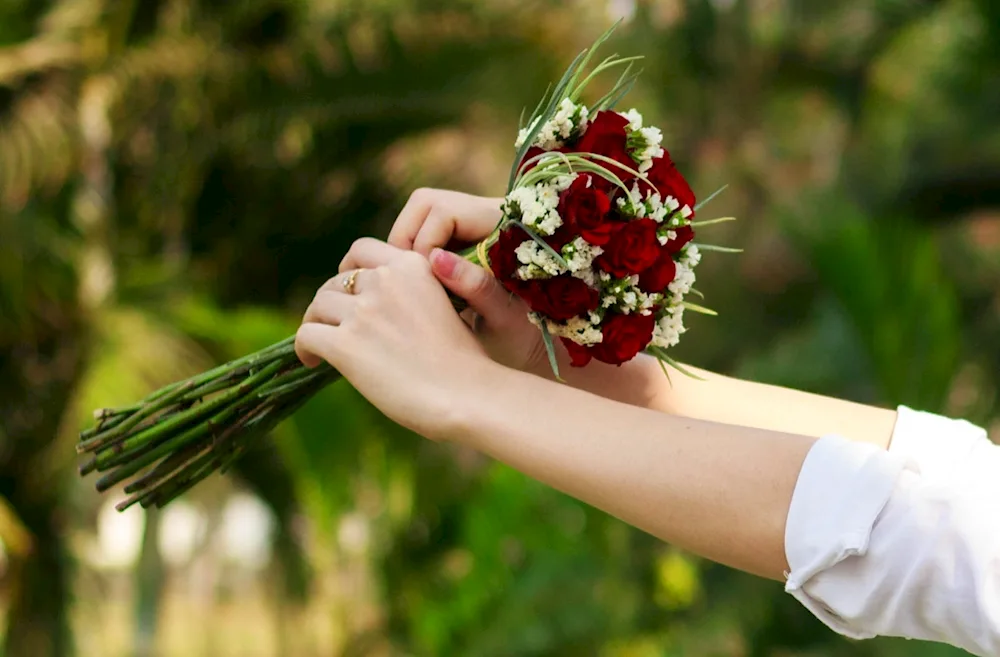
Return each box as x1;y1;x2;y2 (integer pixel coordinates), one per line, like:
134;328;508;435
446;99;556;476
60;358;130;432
388;189;551;375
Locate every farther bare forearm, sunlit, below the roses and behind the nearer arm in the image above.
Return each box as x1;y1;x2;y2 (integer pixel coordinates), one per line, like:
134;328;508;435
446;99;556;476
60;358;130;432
544;354;896;449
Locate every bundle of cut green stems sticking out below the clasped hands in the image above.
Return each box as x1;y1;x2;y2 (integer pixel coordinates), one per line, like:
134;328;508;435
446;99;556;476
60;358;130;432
76;258;478;511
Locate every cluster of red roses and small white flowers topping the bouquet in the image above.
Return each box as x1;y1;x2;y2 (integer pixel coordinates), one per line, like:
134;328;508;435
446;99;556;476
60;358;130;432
476;30;729;368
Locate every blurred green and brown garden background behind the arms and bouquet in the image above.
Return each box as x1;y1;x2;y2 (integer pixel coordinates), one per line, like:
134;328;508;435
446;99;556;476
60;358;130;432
0;0;1000;657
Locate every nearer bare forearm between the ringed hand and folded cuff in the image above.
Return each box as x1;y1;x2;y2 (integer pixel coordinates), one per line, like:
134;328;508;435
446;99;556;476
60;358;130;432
455;358;814;579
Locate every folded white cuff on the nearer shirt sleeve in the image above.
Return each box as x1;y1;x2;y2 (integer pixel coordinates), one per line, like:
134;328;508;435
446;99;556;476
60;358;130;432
785;436;906;639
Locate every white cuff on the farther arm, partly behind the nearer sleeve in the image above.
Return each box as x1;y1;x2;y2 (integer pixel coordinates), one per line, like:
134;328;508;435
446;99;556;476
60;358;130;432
889;406;991;479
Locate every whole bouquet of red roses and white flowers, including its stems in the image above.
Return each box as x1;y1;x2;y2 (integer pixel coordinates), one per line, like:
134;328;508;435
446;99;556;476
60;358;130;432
77;28;736;510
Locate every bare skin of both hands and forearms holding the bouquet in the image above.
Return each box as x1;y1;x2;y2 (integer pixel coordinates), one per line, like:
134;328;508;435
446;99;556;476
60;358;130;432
296;190;895;580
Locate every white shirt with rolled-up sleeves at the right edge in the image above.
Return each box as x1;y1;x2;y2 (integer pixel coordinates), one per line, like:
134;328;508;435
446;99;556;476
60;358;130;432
785;407;1000;657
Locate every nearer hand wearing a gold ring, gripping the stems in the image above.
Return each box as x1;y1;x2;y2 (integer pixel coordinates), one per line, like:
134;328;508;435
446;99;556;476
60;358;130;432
295;238;498;440
